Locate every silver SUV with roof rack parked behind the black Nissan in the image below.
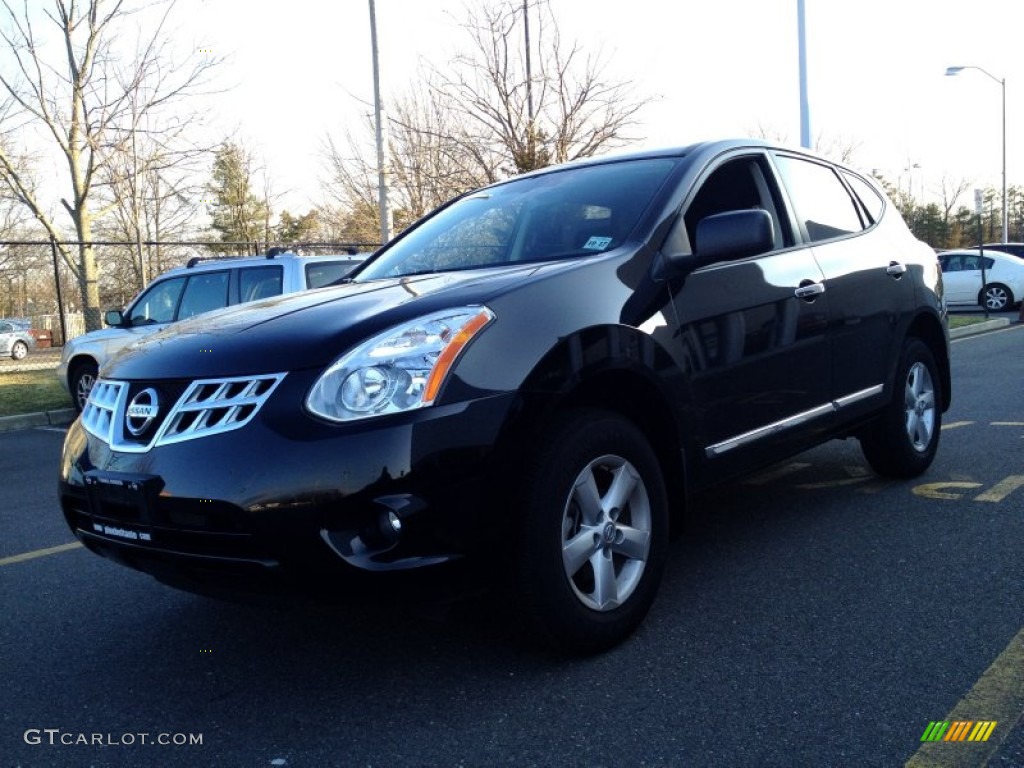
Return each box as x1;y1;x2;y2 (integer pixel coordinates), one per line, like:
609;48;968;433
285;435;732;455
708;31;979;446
57;248;366;411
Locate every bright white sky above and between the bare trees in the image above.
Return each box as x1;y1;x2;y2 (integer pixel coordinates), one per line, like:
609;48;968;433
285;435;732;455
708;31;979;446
119;0;1024;212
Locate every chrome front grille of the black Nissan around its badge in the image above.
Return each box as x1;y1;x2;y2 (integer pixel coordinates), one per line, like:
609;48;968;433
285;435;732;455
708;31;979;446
82;374;285;454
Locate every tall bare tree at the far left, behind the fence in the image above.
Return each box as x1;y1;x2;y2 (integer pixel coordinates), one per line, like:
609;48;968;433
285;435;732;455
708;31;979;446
0;0;216;330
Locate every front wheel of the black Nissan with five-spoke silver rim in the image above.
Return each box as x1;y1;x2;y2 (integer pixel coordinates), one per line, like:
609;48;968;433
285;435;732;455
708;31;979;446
513;409;669;654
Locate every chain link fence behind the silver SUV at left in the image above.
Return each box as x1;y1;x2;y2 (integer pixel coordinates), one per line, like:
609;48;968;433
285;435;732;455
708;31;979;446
0;240;379;349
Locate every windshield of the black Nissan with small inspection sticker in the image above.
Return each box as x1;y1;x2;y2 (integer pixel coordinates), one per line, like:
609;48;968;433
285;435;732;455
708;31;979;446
355;159;676;282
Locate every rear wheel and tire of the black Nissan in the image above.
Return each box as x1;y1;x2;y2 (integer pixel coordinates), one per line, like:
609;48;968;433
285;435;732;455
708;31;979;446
860;338;942;477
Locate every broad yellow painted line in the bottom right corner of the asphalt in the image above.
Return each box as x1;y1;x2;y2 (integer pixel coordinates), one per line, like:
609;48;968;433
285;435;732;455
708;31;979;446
905;629;1024;768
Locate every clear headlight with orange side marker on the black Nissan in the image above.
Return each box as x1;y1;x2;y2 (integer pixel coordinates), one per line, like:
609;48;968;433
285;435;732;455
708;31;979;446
306;306;495;421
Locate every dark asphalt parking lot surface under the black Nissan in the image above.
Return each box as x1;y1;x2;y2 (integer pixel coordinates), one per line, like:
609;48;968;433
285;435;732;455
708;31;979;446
0;326;1024;768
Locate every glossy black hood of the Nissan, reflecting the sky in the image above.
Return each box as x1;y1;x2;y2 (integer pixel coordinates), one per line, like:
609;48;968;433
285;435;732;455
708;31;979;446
104;263;566;380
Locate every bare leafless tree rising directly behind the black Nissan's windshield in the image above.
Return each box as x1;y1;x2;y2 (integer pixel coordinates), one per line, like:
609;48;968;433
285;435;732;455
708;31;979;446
318;0;643;242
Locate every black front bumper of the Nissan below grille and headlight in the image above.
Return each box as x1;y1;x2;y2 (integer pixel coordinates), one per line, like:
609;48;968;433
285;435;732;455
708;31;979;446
59;377;513;593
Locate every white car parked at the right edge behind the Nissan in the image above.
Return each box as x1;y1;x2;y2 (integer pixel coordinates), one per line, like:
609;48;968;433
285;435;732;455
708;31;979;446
939;249;1024;312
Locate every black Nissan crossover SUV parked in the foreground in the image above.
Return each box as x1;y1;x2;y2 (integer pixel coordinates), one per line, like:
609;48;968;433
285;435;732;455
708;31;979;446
59;141;950;652
